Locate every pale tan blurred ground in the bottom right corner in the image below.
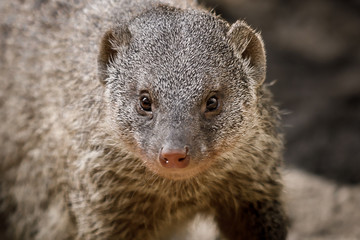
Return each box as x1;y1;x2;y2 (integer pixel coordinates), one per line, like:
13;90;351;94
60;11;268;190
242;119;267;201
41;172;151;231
284;169;360;240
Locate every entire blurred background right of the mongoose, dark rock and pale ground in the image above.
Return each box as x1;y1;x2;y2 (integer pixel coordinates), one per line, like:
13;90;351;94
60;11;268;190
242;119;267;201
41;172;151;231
200;0;360;239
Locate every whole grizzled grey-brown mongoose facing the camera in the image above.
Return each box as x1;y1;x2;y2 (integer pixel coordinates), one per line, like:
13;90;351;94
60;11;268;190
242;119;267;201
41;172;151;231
0;0;287;240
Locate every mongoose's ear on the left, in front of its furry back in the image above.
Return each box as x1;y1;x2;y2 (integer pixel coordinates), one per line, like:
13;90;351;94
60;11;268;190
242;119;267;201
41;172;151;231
97;27;131;84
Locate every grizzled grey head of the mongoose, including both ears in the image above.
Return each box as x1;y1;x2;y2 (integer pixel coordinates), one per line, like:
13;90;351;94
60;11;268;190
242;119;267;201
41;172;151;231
98;6;266;179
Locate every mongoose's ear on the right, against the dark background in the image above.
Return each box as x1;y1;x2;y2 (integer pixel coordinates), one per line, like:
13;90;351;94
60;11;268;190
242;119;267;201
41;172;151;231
228;20;266;85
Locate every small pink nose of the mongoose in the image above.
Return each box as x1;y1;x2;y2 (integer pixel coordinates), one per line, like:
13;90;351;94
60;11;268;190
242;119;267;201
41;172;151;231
159;147;190;168
